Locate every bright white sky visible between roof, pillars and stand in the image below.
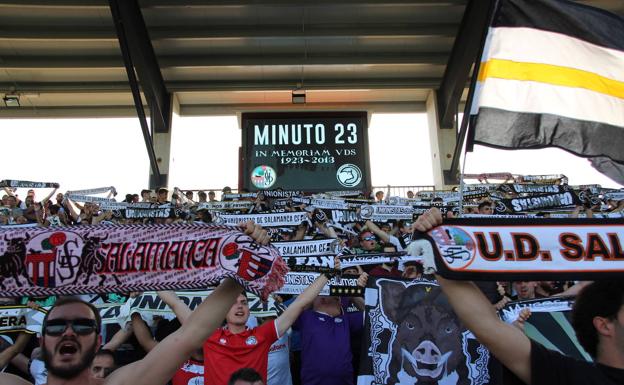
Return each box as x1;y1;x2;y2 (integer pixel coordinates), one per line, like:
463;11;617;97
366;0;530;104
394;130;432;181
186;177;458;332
0;113;621;197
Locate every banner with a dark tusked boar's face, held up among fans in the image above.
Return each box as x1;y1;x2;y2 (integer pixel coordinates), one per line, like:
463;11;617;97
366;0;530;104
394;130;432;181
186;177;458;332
358;278;490;385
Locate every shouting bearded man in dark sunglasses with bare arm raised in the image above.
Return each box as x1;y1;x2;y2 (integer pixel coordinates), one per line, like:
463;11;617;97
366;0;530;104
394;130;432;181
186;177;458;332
0;222;269;385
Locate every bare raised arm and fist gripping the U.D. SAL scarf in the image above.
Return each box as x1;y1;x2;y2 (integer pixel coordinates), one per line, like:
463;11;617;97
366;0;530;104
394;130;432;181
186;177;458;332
414;208;531;385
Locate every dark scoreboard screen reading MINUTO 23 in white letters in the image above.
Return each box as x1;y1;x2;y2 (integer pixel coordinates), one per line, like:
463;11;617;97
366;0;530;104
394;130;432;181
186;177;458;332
241;111;370;192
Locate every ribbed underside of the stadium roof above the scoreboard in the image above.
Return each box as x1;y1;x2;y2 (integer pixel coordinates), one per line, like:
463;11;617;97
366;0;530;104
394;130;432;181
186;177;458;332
0;0;624;117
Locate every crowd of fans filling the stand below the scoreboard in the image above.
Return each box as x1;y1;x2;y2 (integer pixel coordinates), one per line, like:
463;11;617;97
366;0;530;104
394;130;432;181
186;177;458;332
0;176;624;385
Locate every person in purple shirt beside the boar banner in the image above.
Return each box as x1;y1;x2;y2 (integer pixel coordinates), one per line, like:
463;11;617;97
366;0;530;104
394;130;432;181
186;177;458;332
293;274;367;385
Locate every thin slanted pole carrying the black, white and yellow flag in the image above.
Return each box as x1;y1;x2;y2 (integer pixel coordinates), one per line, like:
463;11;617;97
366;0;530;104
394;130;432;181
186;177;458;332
449;0;500;182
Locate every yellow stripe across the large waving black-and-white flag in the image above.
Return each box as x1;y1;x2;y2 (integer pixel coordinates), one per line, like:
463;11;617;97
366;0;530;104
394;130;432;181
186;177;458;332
479;59;624;99
